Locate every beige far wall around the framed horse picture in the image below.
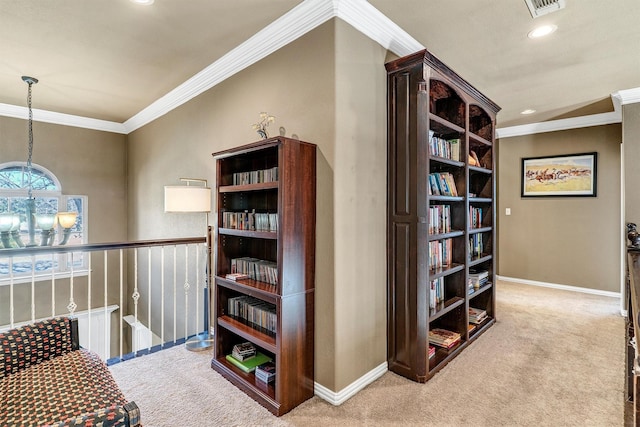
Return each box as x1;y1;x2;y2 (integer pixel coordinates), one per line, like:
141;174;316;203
497;124;622;292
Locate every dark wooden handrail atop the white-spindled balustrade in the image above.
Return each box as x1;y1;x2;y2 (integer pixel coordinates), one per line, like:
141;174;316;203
0;237;207;257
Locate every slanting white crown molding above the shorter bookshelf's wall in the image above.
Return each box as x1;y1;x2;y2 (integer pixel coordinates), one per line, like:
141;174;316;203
124;0;335;132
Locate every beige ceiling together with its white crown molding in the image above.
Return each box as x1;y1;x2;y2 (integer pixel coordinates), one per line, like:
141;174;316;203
0;0;640;133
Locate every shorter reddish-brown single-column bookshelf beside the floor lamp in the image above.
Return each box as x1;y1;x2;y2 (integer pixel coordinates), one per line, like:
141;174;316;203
211;137;316;416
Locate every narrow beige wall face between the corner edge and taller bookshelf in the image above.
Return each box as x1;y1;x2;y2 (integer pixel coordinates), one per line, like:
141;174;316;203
333;20;387;390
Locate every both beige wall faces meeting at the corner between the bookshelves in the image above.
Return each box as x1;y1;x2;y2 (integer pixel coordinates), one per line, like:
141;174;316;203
129;20;387;391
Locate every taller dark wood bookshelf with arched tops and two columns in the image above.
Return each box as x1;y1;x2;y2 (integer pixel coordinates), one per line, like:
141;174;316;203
386;50;500;382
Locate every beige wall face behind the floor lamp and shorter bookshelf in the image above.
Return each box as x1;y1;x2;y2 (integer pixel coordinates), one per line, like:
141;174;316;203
129;21;344;390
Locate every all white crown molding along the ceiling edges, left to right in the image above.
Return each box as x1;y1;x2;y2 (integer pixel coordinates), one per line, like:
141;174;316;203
0;0;640;138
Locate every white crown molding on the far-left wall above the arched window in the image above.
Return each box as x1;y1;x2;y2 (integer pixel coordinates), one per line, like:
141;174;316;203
0;104;128;134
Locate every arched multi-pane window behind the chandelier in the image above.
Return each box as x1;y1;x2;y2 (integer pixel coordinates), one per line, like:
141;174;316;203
0;162;87;284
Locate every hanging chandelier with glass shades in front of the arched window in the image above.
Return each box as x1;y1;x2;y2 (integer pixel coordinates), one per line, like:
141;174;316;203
0;76;78;249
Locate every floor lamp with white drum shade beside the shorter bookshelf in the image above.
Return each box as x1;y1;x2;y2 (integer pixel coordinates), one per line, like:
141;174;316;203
164;178;213;351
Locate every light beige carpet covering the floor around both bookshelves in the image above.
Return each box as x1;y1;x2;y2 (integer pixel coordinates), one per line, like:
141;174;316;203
111;282;625;427
